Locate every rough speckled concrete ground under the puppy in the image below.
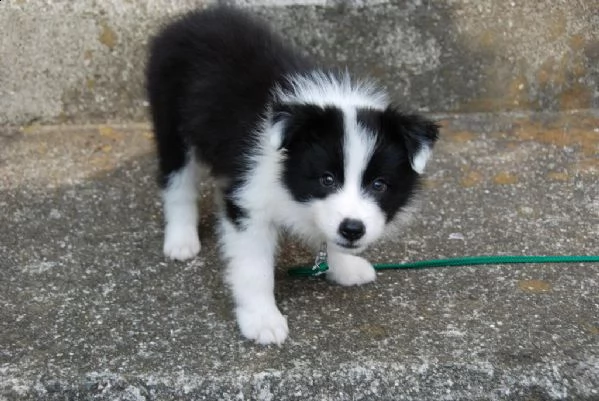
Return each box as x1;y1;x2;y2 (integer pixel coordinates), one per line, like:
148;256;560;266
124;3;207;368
0;112;599;401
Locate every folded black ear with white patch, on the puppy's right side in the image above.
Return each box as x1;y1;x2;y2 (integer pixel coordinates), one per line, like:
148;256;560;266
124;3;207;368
383;107;439;174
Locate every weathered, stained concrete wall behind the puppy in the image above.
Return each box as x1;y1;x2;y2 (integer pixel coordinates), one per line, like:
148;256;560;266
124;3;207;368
0;0;599;124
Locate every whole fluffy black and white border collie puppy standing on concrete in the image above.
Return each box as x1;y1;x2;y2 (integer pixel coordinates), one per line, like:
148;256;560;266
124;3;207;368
147;7;438;344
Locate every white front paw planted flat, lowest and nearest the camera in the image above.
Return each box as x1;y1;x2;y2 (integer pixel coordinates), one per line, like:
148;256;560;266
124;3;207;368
236;305;289;345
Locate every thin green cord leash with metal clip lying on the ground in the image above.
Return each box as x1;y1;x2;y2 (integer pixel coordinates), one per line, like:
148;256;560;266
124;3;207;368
288;255;599;277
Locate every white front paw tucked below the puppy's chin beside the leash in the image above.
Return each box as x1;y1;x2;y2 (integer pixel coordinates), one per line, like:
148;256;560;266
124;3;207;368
327;255;376;286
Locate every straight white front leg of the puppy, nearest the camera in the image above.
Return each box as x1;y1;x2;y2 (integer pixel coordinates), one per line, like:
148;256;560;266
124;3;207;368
221;218;289;345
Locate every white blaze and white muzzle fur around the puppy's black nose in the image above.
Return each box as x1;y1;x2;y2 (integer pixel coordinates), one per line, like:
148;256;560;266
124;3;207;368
314;107;385;248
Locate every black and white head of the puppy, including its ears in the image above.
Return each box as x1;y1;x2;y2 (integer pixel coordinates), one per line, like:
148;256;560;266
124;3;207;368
274;104;438;253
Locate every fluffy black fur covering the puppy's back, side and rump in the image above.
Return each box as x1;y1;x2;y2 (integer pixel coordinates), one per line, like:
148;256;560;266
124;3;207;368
147;7;313;185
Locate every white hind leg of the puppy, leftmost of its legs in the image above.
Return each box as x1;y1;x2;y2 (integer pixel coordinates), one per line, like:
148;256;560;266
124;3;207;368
162;152;200;260
